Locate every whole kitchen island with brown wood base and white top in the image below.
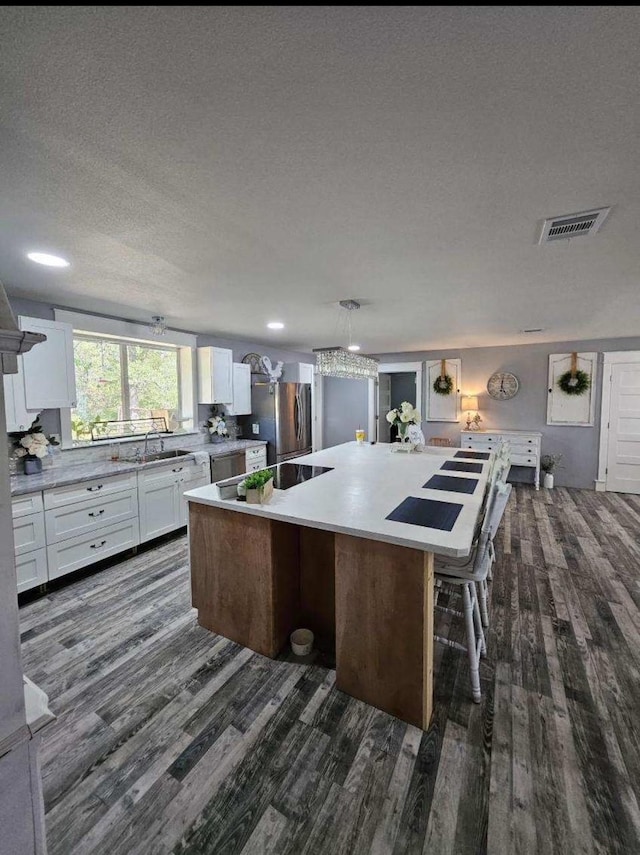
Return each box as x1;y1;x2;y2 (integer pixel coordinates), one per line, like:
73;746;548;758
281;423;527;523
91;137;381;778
185;442;493;728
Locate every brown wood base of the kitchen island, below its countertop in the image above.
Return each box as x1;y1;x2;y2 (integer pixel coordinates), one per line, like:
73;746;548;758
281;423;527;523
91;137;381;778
189;502;433;729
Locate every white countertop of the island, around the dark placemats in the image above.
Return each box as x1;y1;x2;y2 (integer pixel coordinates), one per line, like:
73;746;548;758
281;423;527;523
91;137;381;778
184;442;491;556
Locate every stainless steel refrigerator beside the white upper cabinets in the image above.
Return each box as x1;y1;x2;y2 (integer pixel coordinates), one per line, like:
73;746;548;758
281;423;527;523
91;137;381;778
249;383;311;466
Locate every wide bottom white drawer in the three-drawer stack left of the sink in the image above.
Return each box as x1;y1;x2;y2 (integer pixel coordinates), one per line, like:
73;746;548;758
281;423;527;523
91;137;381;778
47;518;140;579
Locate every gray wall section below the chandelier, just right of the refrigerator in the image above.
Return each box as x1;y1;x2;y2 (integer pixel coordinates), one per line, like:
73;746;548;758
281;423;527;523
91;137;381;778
322;377;373;448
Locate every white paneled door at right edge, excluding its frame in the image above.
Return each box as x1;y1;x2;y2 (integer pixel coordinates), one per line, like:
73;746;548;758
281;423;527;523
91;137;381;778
606;362;640;493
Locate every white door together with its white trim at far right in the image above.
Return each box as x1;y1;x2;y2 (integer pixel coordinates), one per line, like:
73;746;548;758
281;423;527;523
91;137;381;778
596;351;640;494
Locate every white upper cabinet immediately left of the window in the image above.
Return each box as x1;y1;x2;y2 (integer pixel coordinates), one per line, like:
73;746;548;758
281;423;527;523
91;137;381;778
18;316;76;411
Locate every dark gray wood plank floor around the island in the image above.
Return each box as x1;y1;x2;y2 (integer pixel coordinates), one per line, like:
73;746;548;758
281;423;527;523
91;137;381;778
21;486;640;855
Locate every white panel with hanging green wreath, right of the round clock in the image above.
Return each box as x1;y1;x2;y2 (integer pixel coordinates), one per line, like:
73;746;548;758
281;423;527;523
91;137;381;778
547;352;598;427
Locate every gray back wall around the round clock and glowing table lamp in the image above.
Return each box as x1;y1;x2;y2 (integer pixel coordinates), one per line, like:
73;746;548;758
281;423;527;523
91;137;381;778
377;336;640;488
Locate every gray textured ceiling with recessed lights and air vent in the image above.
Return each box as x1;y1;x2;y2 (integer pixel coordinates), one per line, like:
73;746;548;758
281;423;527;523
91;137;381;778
0;6;640;352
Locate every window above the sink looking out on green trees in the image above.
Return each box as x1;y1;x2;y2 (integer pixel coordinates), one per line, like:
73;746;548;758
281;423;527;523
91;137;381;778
71;333;193;442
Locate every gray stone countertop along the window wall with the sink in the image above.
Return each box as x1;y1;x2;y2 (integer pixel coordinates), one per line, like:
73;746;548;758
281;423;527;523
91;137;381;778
11;439;266;496
